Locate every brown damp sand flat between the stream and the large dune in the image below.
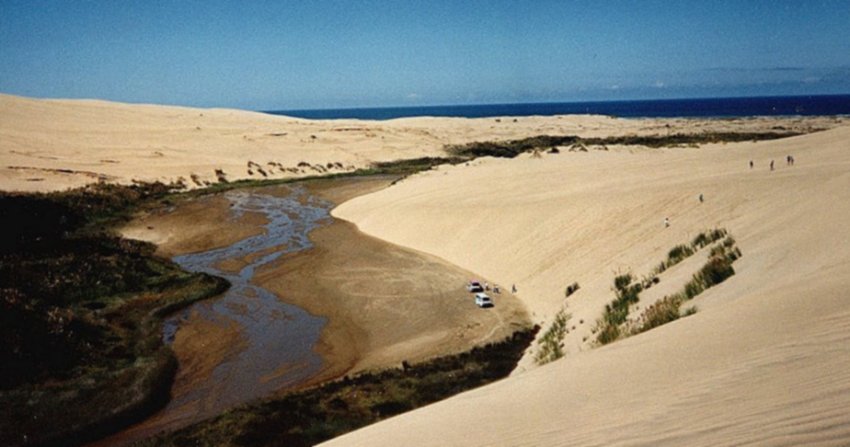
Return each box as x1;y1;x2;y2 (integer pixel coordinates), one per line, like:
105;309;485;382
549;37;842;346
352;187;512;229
257;214;528;377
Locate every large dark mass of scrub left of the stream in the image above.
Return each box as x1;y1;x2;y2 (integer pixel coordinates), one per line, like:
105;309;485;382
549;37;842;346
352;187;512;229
0;183;227;445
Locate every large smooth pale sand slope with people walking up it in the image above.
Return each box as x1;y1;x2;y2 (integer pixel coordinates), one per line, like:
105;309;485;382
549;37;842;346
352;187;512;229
329;127;850;446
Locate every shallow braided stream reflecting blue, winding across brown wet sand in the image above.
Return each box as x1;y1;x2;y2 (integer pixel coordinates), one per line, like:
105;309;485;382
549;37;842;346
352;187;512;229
163;188;331;415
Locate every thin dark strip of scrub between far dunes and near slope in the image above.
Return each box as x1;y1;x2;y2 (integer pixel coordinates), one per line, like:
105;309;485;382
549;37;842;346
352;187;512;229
445;132;801;158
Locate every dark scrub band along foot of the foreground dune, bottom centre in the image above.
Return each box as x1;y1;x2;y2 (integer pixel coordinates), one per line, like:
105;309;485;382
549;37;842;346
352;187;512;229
140;327;539;446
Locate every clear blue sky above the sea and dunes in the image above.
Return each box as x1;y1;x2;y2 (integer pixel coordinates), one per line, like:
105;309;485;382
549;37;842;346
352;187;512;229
0;0;850;110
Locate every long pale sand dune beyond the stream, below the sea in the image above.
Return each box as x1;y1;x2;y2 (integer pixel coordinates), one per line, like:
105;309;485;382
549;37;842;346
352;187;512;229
0;94;835;191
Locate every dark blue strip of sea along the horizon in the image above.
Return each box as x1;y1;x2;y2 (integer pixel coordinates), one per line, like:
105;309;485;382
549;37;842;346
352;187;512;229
265;95;850;120
